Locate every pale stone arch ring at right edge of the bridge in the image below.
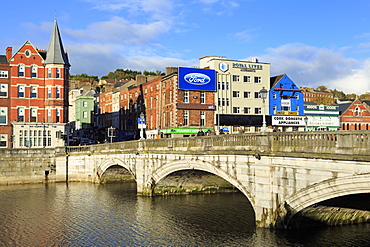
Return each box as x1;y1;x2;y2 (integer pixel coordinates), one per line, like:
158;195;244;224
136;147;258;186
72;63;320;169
280;173;370;227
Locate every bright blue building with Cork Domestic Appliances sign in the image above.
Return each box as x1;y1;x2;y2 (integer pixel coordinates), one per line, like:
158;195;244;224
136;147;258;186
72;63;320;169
269;74;306;131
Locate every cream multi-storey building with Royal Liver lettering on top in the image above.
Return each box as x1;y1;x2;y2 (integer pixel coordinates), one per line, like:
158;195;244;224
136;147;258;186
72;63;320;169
200;56;271;133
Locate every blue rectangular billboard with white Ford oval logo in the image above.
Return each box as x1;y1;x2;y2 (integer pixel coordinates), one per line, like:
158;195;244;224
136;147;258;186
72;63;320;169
178;67;216;91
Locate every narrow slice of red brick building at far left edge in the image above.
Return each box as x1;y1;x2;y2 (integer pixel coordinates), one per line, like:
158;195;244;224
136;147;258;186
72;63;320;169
0;55;12;148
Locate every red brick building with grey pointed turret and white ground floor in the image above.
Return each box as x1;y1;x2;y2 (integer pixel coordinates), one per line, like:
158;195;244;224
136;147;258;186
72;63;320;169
6;21;70;148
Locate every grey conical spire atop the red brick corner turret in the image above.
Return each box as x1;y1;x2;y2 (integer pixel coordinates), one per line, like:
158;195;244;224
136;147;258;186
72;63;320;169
45;20;70;66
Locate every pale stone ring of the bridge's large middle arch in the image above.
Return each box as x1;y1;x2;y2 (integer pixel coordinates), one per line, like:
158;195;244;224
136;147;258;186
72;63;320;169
150;160;255;208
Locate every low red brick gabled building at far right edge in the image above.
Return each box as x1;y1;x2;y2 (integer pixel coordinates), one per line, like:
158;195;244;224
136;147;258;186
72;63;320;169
339;99;370;130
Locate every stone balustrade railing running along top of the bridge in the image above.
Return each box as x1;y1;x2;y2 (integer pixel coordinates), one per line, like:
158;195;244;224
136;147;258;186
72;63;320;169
66;131;370;158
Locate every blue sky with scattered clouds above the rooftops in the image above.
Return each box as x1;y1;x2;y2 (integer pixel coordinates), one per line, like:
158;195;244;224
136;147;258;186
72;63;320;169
0;0;370;94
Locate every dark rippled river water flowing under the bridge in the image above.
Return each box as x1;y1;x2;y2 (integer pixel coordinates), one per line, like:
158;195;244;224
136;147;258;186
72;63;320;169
0;183;370;247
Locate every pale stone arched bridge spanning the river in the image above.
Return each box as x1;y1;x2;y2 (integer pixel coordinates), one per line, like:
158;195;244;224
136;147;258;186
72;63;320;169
56;131;370;227
